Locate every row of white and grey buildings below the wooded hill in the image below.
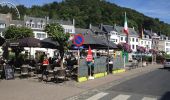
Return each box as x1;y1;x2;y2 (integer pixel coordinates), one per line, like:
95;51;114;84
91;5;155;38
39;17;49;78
0;14;170;55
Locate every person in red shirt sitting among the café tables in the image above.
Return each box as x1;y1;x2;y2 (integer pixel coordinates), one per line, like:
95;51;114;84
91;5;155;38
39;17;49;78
41;56;49;80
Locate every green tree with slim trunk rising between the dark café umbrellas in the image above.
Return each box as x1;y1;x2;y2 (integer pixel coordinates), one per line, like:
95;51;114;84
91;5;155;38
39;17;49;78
45;23;70;68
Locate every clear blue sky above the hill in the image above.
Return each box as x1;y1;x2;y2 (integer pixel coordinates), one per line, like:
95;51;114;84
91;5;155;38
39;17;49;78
0;0;170;24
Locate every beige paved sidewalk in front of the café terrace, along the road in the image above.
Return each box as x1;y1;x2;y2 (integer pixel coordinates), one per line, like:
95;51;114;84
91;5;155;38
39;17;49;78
0;65;160;100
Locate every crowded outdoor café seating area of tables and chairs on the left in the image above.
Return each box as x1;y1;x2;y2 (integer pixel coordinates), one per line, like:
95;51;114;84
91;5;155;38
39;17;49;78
0;60;77;83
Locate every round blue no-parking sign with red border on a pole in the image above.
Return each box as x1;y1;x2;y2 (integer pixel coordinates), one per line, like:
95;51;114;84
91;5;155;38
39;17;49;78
73;34;84;47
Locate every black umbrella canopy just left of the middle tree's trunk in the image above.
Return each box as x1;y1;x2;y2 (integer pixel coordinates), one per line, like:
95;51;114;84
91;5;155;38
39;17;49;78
41;38;59;49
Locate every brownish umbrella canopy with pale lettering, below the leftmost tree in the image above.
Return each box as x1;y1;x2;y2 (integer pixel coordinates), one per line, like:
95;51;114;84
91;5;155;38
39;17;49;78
10;37;41;47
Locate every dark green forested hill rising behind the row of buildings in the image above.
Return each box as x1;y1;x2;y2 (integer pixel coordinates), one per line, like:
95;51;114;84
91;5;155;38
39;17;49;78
0;0;170;35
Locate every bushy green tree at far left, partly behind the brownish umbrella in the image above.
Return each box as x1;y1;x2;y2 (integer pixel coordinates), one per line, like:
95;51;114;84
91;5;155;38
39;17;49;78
3;26;34;59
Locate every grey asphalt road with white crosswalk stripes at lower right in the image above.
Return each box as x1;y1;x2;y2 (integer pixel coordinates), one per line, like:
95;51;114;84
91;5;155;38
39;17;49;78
68;68;170;100
